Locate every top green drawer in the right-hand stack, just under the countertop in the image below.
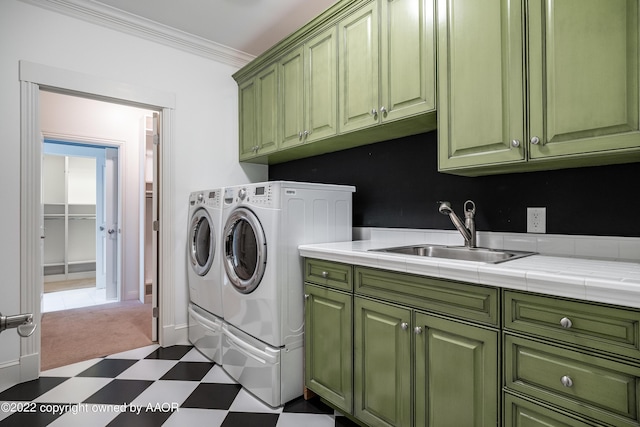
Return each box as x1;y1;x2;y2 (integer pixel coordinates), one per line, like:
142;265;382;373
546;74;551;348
504;291;640;360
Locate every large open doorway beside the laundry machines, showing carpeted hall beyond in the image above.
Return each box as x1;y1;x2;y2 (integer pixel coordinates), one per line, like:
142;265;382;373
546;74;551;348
40;90;157;370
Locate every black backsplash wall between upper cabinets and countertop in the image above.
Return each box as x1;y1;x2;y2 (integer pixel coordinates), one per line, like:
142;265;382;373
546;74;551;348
269;131;640;237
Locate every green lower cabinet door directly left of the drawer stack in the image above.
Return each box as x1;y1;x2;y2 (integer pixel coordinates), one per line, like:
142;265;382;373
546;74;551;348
414;312;500;427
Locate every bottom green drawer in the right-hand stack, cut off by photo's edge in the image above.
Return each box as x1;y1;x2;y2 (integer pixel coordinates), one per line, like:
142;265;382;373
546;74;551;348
504;393;594;427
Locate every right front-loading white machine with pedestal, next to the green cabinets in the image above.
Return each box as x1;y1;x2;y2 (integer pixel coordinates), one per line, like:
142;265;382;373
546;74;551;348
222;181;355;407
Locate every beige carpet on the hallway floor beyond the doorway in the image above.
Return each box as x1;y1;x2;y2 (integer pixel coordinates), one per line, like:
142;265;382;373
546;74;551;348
41;301;152;371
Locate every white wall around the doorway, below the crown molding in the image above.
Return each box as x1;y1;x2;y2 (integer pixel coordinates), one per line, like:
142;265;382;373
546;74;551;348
0;0;267;374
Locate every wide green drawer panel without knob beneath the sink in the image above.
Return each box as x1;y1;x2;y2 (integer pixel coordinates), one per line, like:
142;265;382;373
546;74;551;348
354;267;499;326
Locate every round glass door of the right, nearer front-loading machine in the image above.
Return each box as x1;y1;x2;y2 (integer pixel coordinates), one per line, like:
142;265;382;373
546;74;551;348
224;208;267;294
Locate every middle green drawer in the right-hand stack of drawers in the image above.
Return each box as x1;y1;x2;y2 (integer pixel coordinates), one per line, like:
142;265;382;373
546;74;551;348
504;334;640;426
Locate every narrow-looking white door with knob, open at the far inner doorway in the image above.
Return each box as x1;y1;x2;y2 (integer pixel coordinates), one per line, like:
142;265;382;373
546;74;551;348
104;148;120;299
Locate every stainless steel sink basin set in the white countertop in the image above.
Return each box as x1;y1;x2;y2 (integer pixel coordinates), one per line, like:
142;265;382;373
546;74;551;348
369;245;535;264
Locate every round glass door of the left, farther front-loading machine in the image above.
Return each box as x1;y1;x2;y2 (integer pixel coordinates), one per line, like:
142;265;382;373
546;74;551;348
188;208;216;276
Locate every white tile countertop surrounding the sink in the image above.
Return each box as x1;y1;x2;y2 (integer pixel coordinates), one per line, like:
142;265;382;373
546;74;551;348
299;231;640;308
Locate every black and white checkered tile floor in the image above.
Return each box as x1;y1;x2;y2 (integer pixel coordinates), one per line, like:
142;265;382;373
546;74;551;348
0;345;356;427
